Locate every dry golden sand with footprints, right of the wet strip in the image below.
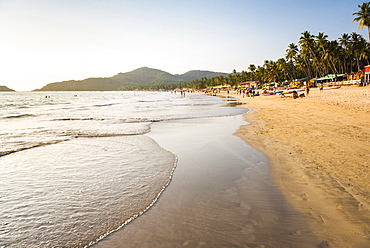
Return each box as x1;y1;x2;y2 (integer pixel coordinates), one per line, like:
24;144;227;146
231;86;370;248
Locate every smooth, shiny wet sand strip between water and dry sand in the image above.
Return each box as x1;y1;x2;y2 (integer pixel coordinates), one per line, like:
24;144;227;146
93;116;320;248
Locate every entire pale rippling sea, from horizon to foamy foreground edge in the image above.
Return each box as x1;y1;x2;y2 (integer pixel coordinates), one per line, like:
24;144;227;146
0;92;247;247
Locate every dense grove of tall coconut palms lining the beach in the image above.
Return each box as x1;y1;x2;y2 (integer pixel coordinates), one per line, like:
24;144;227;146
138;2;370;90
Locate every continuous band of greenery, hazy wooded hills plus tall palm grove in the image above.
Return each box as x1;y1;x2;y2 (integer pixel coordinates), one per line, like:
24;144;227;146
36;3;370;90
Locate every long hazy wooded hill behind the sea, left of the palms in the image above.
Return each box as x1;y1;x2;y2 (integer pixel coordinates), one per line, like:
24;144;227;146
36;67;228;91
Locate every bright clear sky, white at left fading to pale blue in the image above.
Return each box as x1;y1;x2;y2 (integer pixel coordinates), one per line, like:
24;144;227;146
0;0;367;91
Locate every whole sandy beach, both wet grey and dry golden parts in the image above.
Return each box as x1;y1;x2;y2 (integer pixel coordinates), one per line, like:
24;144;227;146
93;87;370;248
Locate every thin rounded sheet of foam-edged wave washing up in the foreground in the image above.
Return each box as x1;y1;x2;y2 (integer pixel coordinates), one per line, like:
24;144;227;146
0;136;175;247
